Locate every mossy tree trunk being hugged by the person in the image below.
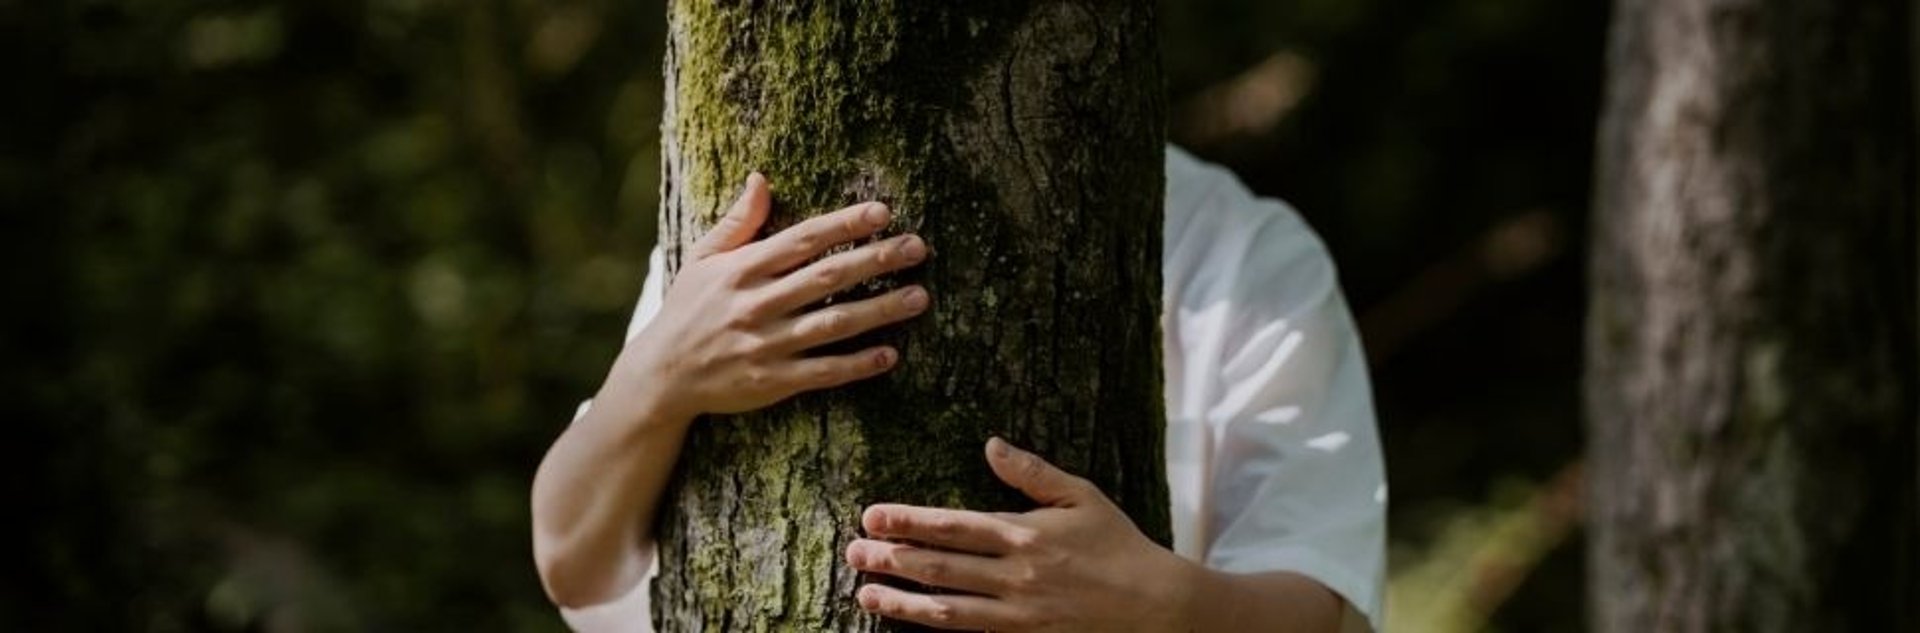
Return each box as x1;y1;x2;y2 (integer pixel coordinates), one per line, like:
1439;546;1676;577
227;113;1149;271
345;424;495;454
653;0;1169;631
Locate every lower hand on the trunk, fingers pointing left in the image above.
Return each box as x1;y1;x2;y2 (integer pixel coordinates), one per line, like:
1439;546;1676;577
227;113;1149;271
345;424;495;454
847;437;1200;631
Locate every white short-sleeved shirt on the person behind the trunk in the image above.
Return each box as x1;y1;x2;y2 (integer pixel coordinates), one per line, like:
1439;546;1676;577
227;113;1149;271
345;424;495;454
563;146;1386;631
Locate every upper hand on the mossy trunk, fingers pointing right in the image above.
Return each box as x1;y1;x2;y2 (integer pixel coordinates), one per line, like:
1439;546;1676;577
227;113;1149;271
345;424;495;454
609;175;927;424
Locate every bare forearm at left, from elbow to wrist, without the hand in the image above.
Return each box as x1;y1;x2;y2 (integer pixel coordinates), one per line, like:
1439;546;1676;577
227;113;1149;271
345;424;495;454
534;351;691;608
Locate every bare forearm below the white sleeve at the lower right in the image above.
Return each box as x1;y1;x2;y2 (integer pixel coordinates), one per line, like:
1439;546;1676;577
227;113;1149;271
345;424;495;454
1187;564;1342;633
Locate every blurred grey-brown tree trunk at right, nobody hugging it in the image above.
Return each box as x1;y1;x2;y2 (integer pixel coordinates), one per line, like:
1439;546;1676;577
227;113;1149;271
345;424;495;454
1586;0;1920;633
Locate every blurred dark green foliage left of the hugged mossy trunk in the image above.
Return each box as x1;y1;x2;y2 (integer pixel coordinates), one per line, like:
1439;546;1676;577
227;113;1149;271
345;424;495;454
8;2;659;629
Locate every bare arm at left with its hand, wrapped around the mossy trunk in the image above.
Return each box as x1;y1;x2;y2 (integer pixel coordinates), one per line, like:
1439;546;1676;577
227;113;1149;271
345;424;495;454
534;175;927;608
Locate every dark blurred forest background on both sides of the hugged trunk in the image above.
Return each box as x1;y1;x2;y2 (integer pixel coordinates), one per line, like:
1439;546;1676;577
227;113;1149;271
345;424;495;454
0;0;1607;631
